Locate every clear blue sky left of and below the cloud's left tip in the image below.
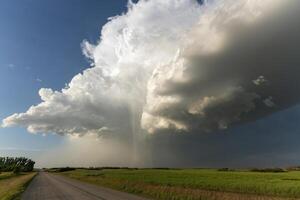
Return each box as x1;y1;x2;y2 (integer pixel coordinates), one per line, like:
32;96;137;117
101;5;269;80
0;0;127;158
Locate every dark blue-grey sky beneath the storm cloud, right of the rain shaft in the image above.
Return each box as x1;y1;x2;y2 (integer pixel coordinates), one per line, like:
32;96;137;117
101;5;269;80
147;106;300;168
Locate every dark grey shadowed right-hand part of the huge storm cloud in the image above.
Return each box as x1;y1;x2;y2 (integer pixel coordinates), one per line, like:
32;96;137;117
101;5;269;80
145;1;300;132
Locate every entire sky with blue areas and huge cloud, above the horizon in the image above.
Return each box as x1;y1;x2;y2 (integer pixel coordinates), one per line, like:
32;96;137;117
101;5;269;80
0;0;300;167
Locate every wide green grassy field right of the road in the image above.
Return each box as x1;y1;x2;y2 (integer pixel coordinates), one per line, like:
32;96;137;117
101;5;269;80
62;169;300;200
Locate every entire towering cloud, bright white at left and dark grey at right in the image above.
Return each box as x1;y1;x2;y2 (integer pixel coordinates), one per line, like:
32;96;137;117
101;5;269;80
3;0;300;137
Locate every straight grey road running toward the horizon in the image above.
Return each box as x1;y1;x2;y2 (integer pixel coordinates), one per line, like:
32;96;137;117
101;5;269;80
21;172;146;200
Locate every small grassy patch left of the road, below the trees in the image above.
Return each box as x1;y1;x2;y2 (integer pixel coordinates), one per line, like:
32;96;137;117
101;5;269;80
0;172;35;200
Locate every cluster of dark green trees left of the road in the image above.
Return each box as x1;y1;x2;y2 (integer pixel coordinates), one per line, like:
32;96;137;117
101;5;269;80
0;157;35;173
